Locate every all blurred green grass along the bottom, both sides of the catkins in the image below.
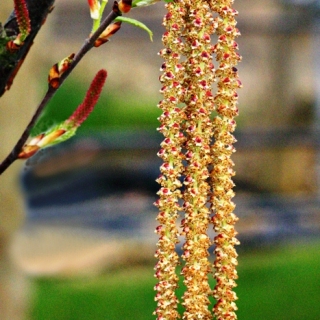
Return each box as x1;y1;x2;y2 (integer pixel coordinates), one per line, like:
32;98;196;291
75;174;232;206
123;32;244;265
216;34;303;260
31;243;320;320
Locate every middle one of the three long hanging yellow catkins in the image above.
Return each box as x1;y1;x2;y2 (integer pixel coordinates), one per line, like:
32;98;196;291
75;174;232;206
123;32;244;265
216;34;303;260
182;0;214;319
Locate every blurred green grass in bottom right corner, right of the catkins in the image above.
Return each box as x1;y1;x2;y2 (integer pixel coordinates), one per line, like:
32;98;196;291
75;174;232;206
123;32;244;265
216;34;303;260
237;243;320;320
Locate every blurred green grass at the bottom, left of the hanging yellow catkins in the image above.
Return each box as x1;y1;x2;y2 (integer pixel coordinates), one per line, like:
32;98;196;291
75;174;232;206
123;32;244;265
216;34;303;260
32;267;155;320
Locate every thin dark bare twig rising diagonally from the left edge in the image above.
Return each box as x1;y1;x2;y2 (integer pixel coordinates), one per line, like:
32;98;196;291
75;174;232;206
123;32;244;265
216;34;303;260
0;4;121;175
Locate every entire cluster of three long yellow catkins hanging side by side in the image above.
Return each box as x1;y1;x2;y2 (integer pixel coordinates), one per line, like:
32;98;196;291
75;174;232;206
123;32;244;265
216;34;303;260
154;0;241;320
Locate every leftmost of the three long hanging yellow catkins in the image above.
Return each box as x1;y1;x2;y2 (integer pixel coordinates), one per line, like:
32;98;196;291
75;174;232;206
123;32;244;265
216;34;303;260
154;3;185;320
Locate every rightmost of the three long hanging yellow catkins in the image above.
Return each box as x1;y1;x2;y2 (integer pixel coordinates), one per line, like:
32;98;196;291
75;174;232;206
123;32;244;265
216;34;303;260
209;0;241;320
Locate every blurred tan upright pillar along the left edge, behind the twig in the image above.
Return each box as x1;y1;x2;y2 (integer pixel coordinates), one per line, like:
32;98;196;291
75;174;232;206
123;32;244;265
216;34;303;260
0;1;44;320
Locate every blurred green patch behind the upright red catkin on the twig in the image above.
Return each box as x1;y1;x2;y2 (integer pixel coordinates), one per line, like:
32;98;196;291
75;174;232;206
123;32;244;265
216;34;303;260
32;81;161;135
